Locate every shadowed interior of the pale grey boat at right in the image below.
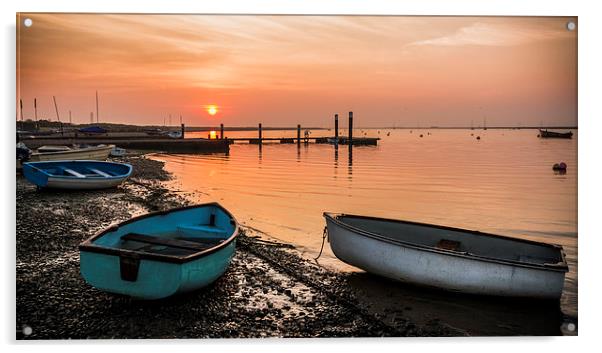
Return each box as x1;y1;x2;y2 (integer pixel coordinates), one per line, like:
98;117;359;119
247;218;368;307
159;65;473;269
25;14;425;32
337;215;564;265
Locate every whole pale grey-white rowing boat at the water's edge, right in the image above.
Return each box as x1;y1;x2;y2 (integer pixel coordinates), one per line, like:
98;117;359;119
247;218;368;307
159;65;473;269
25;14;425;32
324;213;568;299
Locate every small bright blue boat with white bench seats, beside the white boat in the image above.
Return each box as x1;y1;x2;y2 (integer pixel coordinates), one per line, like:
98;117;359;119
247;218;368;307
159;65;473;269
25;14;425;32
23;161;132;190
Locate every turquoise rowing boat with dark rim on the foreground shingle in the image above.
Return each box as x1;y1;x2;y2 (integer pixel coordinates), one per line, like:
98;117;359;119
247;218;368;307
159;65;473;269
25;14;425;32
79;203;238;300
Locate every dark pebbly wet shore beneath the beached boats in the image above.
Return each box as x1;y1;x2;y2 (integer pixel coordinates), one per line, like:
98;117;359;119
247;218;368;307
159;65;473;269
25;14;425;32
16;156;562;339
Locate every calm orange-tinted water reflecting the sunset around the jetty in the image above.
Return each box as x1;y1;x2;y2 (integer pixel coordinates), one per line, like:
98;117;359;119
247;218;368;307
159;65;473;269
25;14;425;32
154;129;577;316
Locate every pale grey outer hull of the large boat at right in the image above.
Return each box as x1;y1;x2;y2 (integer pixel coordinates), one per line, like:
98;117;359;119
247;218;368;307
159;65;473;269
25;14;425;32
326;213;564;299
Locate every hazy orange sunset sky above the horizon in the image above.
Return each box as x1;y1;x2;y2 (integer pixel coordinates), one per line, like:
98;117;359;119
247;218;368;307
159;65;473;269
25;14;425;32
17;13;577;127
